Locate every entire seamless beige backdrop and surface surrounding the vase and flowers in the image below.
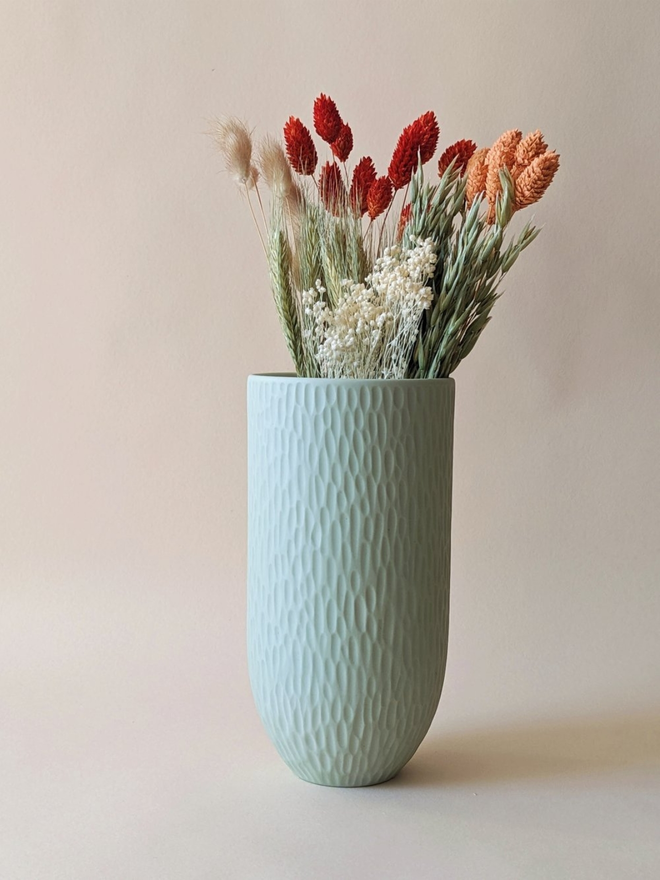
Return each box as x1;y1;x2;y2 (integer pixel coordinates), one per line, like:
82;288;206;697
0;0;660;880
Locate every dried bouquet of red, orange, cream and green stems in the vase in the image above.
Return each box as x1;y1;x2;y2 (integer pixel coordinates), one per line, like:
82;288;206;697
212;95;559;379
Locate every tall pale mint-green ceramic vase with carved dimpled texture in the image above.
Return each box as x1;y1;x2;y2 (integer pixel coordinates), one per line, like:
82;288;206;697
248;375;454;786
